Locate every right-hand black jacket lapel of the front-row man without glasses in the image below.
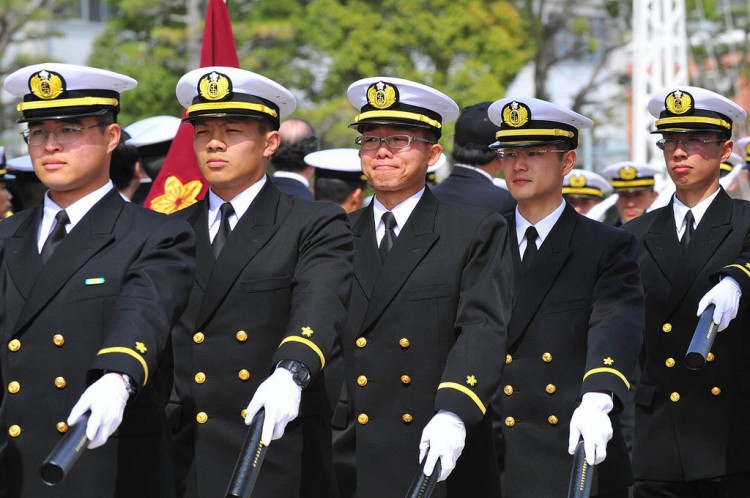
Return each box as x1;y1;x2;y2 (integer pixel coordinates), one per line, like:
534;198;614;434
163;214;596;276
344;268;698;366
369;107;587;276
196;178;286;328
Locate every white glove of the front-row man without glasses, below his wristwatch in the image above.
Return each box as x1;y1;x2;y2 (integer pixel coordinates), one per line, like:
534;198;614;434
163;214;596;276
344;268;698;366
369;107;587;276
245;368;302;446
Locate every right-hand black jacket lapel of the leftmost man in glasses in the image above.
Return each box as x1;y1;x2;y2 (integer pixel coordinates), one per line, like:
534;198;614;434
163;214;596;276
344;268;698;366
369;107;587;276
14;189;125;333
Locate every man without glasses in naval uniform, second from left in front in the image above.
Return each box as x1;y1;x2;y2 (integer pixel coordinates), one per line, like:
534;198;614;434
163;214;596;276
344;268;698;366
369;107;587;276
170;67;352;498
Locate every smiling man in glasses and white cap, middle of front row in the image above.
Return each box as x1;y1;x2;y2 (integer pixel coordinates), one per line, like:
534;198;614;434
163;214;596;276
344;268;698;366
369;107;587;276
334;78;512;498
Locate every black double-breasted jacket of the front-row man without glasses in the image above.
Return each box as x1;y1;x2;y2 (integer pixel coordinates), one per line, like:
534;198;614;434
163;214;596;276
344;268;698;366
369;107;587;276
173;181;352;498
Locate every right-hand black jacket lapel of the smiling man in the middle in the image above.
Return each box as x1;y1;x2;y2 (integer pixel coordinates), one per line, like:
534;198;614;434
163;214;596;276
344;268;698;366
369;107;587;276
362;189;439;330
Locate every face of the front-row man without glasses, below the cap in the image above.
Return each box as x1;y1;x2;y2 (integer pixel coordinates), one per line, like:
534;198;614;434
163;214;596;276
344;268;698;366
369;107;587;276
193;118;280;201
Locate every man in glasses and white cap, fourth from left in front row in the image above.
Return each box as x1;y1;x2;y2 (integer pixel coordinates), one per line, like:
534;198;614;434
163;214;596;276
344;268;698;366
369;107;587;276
488;98;643;498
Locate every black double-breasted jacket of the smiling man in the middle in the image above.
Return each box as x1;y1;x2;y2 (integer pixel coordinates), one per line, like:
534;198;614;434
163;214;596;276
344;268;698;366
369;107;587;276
342;188;512;498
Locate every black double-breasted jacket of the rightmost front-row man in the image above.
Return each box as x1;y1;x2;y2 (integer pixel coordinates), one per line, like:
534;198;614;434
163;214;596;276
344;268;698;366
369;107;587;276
623;189;750;481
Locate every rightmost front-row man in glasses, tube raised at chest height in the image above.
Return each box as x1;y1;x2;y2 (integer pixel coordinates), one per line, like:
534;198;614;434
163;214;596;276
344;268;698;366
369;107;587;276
624;86;750;497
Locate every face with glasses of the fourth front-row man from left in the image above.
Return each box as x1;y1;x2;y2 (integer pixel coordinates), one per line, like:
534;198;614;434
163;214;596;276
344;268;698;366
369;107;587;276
503;144;576;204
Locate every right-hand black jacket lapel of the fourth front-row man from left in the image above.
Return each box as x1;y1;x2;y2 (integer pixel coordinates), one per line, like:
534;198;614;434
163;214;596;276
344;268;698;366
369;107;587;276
508;204;579;348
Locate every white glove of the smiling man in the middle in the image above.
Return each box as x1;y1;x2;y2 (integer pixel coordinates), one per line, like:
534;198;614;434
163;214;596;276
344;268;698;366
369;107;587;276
419;410;466;481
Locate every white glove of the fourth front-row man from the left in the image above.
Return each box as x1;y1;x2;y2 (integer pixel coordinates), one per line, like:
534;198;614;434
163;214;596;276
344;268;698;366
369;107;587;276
568;393;614;465
